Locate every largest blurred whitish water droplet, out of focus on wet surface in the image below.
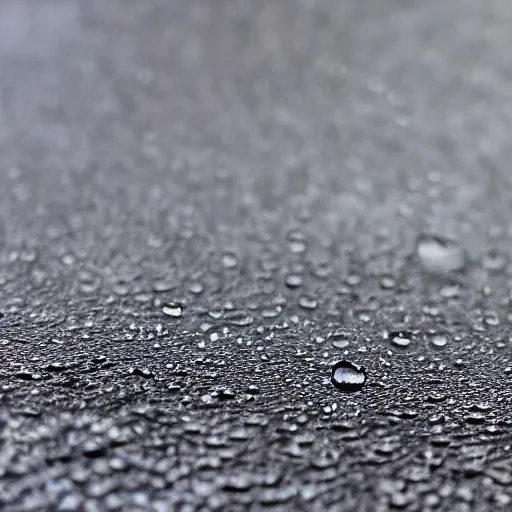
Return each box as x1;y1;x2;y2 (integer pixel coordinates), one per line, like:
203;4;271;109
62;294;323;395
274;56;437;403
416;235;467;273
